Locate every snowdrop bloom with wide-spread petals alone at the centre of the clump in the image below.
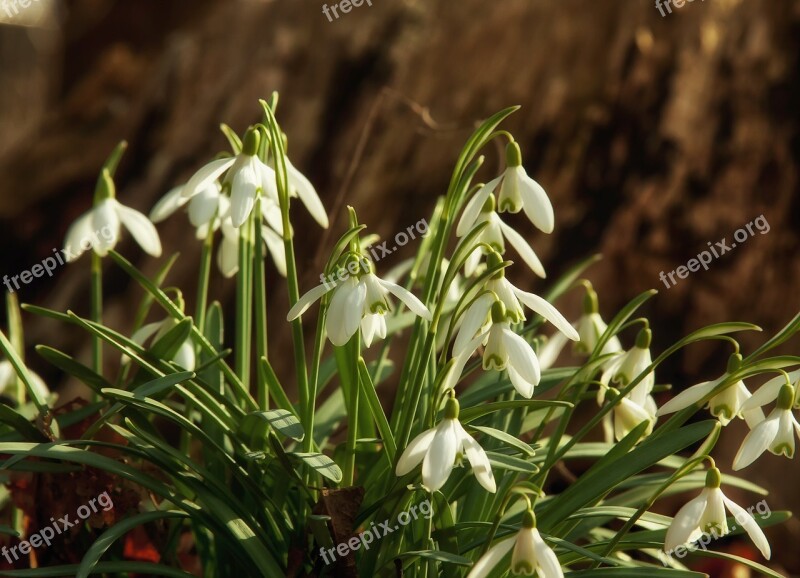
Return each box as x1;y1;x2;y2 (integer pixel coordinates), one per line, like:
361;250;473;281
286;254;432;347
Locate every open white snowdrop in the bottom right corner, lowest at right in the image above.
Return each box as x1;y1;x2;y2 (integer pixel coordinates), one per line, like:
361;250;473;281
664;467;771;560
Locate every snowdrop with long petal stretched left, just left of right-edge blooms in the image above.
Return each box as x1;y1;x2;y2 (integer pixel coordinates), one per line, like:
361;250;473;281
658;353;764;429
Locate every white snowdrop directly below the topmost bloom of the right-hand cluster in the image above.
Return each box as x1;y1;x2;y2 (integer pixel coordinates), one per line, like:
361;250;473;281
456;191;546;279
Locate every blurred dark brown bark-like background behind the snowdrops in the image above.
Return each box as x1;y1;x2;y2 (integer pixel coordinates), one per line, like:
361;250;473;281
0;0;800;573
